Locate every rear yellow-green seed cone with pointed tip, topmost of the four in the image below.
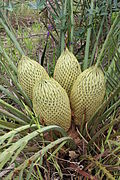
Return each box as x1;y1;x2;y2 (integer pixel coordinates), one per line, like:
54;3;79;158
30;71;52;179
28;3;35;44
54;48;81;96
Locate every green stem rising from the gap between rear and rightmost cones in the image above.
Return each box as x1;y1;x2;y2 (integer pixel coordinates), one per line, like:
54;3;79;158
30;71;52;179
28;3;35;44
83;0;94;69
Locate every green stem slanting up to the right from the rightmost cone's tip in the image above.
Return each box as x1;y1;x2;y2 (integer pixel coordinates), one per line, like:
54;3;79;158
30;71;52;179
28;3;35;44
95;13;120;67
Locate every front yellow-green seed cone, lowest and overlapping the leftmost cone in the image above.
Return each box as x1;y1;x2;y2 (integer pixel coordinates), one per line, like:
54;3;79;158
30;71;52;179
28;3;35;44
33;79;71;131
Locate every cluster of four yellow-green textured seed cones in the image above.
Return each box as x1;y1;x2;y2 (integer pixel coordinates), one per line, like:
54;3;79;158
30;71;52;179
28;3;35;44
18;48;106;131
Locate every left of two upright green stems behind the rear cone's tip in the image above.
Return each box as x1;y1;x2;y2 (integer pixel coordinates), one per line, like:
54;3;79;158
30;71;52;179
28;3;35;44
60;0;67;53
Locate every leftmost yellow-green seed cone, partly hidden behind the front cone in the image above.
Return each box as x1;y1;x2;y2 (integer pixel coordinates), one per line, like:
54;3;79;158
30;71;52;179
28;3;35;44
18;56;49;99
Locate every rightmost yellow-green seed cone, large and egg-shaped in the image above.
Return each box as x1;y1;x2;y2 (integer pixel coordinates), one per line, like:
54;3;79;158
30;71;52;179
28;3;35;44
70;66;106;125
